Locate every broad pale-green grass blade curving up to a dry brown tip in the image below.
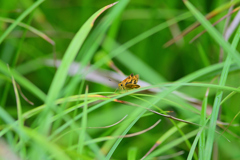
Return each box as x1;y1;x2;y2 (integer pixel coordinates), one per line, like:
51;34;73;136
38;4;117;132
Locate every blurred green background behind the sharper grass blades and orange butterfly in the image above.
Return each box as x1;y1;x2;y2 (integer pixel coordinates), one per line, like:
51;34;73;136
0;0;240;159
